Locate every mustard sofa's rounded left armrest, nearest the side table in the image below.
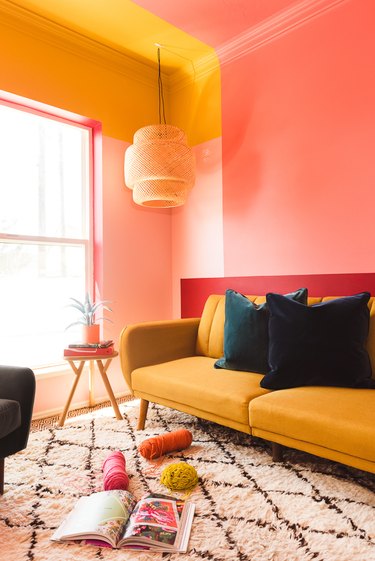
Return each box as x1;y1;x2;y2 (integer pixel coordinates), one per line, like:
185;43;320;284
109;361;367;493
119;318;200;390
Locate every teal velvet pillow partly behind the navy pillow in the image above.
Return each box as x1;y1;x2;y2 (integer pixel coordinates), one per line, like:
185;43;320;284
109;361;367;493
215;288;307;374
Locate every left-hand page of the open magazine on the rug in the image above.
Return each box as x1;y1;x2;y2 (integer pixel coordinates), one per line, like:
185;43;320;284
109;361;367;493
52;490;136;547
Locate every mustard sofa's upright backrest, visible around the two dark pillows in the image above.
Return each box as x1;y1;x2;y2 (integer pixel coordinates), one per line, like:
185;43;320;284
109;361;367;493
196;294;375;378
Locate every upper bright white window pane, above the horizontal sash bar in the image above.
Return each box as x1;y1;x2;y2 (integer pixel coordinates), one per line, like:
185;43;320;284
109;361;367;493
0;105;89;238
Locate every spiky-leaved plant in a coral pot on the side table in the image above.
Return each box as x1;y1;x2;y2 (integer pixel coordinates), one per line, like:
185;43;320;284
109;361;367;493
66;292;112;344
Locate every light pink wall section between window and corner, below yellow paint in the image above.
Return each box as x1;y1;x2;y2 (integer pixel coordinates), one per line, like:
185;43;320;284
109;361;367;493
103;137;172;384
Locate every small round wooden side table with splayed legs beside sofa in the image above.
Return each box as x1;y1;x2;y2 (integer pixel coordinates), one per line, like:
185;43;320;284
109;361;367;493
58;351;122;427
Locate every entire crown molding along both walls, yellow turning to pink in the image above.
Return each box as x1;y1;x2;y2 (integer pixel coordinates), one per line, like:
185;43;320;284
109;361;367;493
0;0;347;93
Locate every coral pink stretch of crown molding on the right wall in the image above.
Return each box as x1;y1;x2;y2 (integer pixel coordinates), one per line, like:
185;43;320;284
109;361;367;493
216;0;347;65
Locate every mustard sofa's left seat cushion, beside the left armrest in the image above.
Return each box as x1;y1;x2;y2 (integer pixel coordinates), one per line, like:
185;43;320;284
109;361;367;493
131;356;268;425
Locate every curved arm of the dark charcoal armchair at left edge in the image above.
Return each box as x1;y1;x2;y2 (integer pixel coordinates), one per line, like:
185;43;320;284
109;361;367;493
0;365;35;458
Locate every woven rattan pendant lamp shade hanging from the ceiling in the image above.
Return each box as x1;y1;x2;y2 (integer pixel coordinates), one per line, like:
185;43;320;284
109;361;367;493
125;124;195;208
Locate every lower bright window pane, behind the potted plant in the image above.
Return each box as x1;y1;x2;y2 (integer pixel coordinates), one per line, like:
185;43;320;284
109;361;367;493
0;243;85;367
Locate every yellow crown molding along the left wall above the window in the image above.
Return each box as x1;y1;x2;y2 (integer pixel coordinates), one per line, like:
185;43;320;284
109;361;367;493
0;0;156;87
